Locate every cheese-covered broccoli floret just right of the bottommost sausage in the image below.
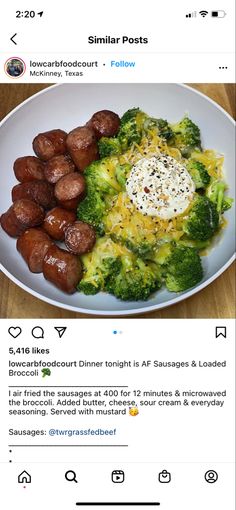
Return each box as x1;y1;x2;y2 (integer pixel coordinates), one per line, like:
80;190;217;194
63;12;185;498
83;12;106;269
77;237;120;295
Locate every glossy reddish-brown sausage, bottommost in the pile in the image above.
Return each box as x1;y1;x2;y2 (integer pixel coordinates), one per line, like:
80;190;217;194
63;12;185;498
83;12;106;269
43;244;82;294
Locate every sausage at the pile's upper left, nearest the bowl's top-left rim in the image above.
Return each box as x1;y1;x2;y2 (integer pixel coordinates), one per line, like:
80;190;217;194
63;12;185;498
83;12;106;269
33;129;67;161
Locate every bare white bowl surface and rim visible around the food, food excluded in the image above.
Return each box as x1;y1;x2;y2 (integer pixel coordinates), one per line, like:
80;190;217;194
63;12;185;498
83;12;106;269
0;84;235;315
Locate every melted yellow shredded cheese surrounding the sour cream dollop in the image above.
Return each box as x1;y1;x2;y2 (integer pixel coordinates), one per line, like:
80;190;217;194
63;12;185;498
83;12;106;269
104;130;224;242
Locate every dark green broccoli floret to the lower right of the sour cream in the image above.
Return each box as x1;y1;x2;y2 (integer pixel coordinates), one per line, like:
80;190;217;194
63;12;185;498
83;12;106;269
183;196;219;241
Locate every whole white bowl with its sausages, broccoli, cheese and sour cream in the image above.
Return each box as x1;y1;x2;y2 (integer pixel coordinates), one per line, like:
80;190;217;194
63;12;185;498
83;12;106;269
0;84;235;317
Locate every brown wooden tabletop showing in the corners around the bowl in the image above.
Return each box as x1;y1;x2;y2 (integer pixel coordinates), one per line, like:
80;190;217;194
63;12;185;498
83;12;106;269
0;84;235;318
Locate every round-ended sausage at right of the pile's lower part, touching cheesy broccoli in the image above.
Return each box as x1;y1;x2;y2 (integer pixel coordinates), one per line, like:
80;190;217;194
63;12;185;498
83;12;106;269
65;221;96;255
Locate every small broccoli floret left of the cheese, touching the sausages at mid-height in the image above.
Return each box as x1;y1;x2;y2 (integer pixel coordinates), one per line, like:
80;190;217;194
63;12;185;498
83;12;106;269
77;186;106;236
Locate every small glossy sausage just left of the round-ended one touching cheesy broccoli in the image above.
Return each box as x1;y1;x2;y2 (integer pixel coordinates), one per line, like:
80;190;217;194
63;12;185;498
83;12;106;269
43;207;76;241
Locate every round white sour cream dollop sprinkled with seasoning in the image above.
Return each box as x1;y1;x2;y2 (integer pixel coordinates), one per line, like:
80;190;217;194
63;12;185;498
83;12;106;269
126;154;195;220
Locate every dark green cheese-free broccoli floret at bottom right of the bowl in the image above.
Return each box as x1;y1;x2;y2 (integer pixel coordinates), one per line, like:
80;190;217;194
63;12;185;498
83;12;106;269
164;246;203;292
